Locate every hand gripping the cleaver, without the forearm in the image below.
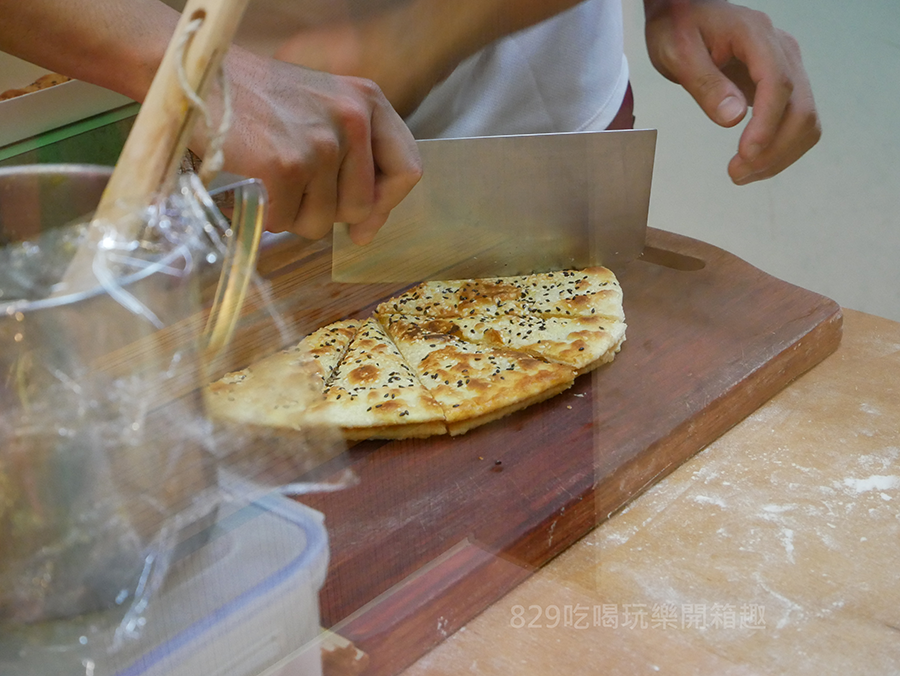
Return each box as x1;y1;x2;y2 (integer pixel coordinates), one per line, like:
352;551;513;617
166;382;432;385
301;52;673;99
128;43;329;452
207;47;422;244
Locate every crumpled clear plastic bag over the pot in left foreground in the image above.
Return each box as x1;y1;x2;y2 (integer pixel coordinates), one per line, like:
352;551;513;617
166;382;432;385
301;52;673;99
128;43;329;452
0;165;352;661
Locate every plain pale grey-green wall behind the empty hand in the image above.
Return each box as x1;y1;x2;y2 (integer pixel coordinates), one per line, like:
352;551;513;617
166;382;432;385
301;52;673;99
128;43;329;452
624;0;900;321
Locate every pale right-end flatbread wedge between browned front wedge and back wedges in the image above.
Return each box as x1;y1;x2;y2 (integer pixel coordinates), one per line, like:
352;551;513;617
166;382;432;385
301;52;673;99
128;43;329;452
441;315;626;375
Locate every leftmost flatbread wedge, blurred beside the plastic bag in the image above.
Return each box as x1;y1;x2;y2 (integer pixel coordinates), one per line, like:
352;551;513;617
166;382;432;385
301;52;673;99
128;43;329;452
204;319;360;429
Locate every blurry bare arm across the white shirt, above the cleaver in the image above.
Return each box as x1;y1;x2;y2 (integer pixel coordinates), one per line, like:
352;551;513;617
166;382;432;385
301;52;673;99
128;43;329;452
276;0;582;116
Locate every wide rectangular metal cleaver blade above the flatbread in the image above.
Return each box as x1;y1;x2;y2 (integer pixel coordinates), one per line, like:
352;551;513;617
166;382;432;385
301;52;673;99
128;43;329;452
332;129;656;282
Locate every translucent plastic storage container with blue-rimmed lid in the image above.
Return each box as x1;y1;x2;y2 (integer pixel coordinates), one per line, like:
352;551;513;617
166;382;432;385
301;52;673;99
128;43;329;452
0;496;328;676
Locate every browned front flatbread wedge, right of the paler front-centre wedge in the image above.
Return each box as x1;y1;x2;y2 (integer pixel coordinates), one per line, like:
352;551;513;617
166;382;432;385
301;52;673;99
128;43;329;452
380;315;576;435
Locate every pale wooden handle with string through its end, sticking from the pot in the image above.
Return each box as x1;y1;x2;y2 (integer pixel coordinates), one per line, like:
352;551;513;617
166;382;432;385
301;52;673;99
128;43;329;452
53;0;249;296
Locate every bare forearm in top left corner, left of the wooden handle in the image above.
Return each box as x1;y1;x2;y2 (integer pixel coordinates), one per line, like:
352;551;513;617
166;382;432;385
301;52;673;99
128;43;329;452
0;0;179;101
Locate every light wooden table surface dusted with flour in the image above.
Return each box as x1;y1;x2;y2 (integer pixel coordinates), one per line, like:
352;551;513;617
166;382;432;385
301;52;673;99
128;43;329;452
404;311;900;676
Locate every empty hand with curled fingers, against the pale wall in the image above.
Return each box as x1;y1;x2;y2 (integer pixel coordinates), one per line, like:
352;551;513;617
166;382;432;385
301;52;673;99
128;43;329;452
644;0;822;185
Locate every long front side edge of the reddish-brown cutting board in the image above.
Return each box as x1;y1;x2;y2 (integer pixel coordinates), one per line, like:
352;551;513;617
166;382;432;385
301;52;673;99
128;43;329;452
336;297;843;676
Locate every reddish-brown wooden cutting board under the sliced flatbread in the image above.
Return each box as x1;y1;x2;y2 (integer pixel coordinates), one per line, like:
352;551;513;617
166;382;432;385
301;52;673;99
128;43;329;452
250;230;842;674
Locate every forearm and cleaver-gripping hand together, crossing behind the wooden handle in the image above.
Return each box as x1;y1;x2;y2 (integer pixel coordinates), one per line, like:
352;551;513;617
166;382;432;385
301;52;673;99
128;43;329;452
0;0;421;243
